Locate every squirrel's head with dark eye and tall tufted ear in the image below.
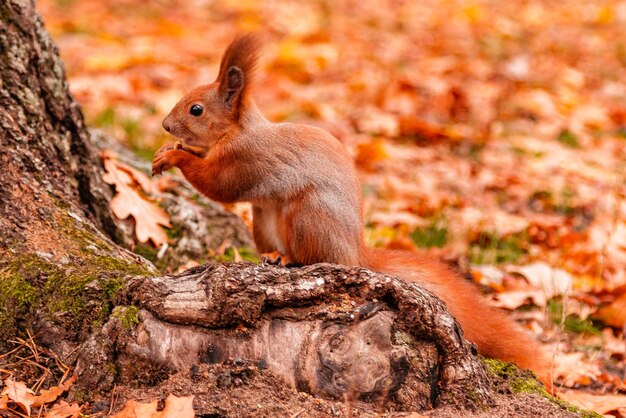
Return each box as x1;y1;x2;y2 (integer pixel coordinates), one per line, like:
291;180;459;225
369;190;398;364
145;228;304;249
163;34;261;149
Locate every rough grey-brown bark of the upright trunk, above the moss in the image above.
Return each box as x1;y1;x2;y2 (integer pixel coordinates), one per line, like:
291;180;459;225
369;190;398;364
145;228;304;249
0;0;116;245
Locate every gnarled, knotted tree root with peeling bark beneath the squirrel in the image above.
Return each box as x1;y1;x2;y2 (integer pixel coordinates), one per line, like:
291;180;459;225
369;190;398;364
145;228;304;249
77;263;492;413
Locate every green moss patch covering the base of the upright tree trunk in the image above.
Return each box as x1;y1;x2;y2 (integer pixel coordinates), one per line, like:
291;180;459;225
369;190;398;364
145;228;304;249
0;211;156;340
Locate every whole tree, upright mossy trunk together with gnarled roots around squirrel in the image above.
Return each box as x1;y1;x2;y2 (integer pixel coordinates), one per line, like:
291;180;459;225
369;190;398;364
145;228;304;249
0;0;580;416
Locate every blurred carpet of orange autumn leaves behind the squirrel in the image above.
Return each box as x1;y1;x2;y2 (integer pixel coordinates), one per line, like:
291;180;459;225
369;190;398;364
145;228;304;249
37;0;626;406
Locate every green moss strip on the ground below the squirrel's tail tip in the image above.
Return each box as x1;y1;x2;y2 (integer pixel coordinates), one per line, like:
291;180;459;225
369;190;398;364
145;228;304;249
483;358;602;418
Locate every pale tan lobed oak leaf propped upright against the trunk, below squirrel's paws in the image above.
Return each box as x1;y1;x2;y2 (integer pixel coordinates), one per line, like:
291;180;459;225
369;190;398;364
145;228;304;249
102;154;171;247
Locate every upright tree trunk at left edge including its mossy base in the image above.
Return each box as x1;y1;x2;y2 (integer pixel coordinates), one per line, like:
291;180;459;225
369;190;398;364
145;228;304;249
0;0;155;349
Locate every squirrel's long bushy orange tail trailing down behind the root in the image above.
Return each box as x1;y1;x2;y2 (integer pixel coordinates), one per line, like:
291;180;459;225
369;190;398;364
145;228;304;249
362;248;551;386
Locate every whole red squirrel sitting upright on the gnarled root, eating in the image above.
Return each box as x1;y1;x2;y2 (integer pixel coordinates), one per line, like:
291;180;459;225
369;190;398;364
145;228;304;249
152;34;551;383
